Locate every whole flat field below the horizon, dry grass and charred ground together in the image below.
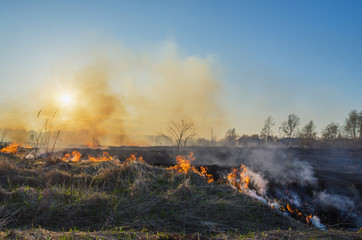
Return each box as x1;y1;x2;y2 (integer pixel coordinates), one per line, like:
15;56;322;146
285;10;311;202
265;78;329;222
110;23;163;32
0;147;362;239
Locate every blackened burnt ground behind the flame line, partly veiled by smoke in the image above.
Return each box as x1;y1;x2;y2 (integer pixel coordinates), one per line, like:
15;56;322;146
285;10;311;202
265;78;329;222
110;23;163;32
59;147;362;229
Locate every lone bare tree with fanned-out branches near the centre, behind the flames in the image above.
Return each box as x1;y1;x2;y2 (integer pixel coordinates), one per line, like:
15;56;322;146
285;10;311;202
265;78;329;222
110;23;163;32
161;120;196;154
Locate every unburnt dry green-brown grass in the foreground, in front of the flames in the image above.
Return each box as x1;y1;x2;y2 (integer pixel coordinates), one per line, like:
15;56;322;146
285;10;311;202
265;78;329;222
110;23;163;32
0;151;362;239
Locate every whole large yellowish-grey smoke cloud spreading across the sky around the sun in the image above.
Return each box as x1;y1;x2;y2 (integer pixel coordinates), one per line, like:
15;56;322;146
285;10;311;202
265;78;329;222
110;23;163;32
0;43;225;145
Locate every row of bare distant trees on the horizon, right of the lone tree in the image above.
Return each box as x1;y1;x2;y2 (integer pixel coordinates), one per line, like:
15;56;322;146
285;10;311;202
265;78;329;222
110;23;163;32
154;110;362;148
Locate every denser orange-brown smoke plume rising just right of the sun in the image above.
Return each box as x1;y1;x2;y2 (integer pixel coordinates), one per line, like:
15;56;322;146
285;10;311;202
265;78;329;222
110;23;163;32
53;65;126;144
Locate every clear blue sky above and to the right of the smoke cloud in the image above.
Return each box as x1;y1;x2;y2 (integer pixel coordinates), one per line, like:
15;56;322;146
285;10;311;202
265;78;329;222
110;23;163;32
0;0;362;137
